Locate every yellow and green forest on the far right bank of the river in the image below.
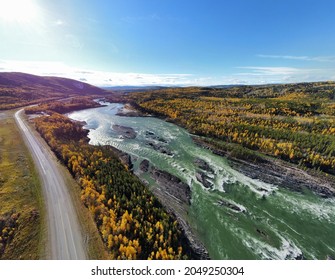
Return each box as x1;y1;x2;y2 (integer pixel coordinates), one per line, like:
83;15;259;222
117;82;335;174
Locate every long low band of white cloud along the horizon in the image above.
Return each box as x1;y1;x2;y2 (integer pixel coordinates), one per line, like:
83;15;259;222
0;60;335;86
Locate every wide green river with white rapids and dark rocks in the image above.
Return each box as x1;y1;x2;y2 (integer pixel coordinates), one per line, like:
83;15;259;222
69;103;335;259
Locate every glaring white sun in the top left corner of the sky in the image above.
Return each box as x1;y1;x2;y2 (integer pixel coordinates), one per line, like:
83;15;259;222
0;0;37;23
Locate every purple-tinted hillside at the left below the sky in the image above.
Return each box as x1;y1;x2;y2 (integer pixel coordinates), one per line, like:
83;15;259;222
0;72;106;110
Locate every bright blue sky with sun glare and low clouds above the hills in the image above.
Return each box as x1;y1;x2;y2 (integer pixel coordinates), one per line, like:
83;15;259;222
0;0;335;86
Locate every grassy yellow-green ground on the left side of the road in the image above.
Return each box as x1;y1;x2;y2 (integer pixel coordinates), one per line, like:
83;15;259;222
0;111;45;259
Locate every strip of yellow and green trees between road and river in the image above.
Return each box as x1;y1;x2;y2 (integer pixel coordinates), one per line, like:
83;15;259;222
28;105;192;260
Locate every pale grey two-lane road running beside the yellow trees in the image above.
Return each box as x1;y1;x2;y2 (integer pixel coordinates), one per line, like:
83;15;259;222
15;109;86;260
